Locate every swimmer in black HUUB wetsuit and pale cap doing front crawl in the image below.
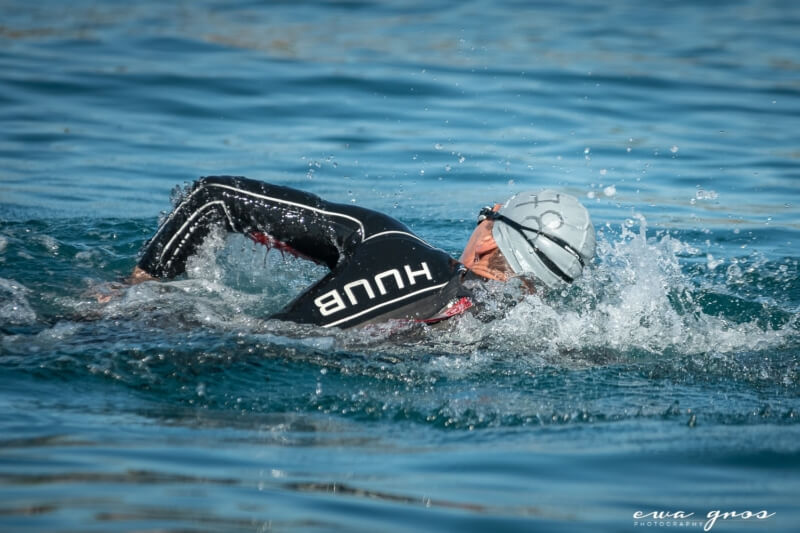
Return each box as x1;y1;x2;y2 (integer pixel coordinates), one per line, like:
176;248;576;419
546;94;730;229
130;176;595;328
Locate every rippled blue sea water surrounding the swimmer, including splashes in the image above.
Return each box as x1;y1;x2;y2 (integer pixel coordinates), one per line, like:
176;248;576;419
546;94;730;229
0;0;800;532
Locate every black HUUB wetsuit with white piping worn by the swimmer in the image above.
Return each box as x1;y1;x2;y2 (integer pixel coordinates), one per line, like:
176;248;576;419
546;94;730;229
139;176;477;328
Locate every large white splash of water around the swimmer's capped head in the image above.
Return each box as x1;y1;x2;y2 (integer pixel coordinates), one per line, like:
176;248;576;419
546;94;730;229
440;217;797;357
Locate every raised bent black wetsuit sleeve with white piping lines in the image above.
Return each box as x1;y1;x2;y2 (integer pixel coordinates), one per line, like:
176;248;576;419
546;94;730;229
138;176;404;278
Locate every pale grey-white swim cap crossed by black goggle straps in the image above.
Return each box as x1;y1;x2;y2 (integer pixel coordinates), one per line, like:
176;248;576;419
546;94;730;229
482;190;595;287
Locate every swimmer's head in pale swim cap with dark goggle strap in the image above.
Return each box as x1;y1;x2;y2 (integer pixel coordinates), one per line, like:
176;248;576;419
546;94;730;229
461;190;595;288
